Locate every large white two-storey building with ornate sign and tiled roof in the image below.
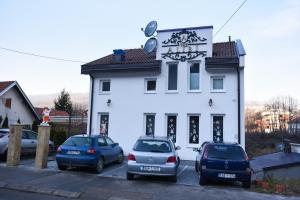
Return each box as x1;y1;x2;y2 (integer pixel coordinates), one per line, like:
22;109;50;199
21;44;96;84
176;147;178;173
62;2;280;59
81;26;246;160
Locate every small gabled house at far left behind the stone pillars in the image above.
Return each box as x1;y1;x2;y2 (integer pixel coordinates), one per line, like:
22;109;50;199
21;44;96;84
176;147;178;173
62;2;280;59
0;81;40;128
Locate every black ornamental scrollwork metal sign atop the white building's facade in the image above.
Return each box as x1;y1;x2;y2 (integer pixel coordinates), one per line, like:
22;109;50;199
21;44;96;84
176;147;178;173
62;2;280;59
162;30;207;62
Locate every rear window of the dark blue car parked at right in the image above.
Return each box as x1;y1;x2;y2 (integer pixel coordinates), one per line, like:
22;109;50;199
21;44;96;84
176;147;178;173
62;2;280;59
207;145;245;160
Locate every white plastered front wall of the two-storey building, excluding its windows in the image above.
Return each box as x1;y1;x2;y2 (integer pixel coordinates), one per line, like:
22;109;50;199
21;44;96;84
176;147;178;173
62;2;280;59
90;29;244;160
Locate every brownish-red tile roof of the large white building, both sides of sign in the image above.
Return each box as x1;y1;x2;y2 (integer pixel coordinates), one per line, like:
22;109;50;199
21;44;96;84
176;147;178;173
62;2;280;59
85;42;237;66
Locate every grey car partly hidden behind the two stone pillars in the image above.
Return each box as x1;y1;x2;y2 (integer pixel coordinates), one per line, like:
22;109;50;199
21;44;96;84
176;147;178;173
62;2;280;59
0;129;54;158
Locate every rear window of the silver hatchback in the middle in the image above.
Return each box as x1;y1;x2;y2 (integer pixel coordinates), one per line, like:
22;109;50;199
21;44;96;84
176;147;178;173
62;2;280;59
133;140;171;153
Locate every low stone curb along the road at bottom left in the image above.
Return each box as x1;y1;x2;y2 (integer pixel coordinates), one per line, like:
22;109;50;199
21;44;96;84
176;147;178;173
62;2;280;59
0;181;81;198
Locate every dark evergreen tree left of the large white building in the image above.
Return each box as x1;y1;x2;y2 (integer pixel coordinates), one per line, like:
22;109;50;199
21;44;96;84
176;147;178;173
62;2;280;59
54;89;73;114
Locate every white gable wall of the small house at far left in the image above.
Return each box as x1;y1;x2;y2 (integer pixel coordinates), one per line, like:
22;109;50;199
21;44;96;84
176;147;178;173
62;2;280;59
0;88;35;126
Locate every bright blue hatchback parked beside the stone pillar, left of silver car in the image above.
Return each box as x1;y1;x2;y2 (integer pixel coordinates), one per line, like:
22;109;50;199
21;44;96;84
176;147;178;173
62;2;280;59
56;135;124;173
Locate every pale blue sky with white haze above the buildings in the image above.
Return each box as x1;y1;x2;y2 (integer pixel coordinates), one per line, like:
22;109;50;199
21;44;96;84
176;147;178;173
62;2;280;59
0;0;300;101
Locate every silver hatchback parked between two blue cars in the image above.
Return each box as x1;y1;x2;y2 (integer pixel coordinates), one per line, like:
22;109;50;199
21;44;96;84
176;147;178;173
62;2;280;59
127;136;180;182
